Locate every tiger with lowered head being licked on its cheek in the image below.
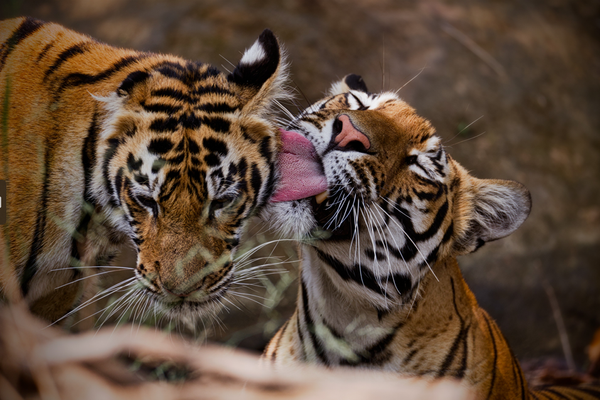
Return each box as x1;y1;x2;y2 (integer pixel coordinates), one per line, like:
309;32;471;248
0;17;289;322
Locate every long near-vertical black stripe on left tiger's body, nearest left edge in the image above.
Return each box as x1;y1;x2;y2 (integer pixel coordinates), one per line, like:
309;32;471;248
21;145;51;296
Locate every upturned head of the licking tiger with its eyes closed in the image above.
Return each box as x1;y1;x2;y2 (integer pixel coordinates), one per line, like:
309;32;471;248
264;75;531;303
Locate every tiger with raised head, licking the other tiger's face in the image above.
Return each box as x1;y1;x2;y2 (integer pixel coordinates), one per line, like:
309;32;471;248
263;75;600;399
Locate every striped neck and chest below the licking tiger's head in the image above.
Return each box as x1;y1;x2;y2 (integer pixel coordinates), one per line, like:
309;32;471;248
297;246;525;393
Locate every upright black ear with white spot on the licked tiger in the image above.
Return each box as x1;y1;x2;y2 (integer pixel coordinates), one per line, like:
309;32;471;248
227;29;288;115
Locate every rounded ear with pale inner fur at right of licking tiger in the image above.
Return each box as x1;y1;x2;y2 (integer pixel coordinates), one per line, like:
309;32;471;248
454;176;531;254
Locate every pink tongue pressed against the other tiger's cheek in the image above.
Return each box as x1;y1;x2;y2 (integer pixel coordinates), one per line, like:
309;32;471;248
271;129;327;203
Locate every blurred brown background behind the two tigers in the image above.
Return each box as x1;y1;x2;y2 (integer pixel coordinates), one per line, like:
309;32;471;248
0;0;600;374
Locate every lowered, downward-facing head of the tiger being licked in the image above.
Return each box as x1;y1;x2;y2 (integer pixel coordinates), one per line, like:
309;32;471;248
93;30;286;315
